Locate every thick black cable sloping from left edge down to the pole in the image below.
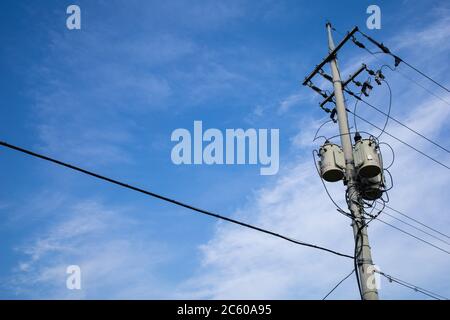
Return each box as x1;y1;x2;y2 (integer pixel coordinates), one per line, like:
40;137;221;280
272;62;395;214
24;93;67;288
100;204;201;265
0;141;353;259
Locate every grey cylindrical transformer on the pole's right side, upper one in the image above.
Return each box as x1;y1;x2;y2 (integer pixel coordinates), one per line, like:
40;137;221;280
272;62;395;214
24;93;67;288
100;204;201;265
353;139;382;178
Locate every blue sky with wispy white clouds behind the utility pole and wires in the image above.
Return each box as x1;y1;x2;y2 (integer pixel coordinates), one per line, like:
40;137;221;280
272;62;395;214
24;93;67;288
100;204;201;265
0;0;450;299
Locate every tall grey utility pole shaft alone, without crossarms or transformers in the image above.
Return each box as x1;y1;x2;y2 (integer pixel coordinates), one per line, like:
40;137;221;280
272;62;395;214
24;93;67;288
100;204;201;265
326;22;378;300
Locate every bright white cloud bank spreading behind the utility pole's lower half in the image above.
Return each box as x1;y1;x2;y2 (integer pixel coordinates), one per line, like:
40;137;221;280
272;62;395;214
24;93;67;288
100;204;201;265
179;11;450;299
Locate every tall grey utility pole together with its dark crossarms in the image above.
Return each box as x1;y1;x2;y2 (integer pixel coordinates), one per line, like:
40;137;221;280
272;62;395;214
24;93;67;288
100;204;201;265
303;22;382;300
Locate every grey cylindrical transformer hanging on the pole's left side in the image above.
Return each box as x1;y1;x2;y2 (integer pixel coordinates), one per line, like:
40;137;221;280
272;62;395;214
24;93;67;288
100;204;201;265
319;142;345;182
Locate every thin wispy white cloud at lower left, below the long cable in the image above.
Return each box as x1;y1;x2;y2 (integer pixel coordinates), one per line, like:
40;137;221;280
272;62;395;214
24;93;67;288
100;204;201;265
10;200;174;299
